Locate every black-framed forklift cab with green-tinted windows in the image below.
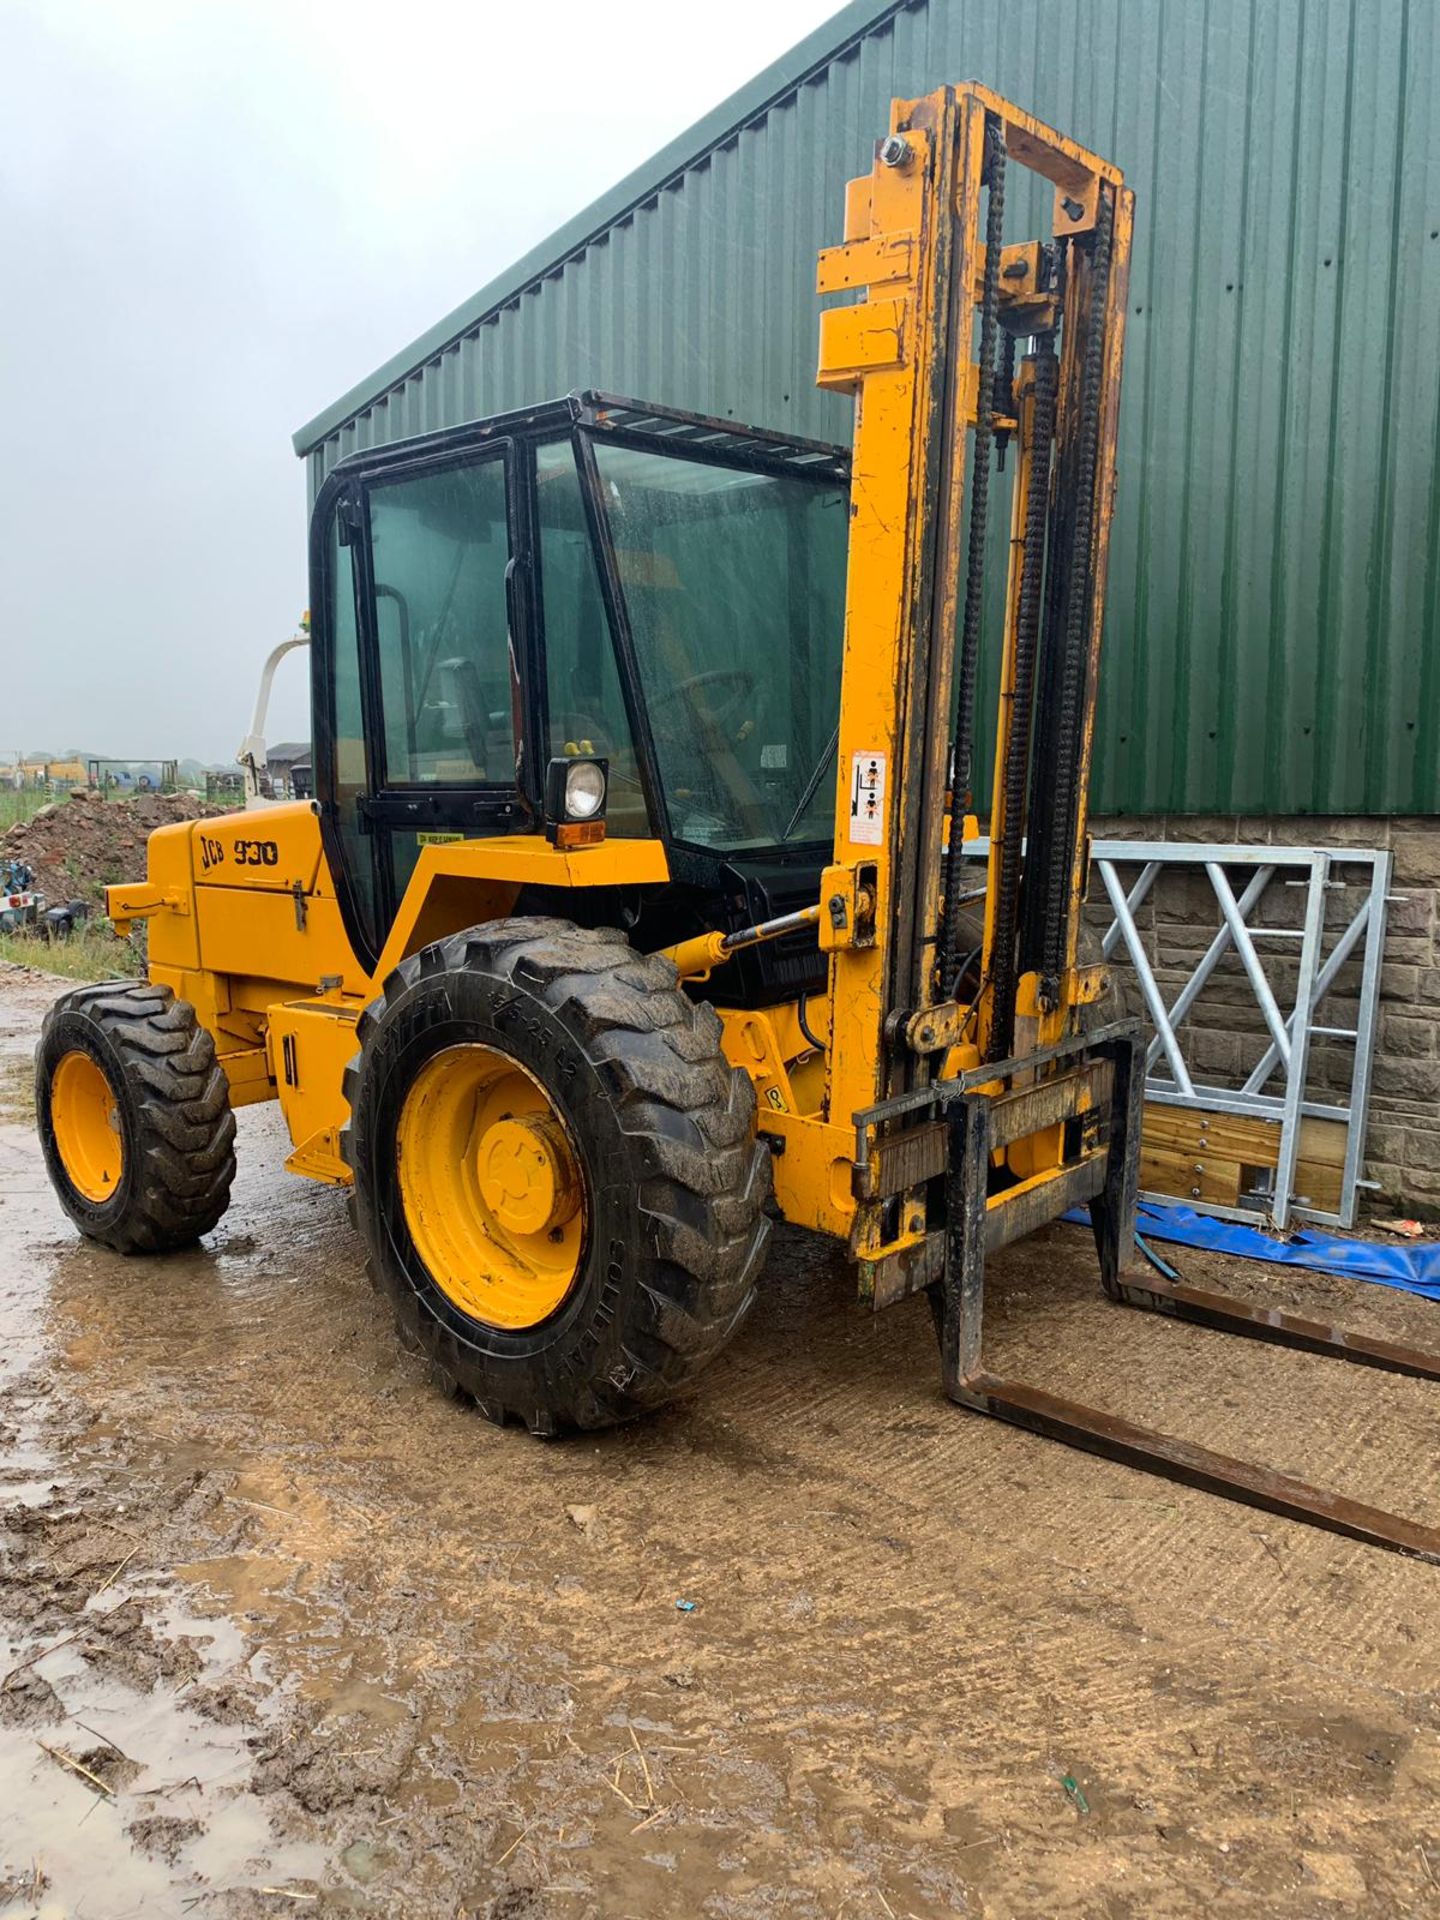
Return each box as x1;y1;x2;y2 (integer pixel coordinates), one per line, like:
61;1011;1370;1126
311;394;849;1004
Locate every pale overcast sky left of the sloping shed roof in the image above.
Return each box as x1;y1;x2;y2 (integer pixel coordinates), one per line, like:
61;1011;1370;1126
0;0;837;760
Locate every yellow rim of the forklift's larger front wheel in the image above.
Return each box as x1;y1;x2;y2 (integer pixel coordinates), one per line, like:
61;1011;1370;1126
396;1046;586;1329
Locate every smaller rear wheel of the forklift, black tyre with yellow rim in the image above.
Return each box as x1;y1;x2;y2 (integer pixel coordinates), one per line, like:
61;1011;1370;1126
35;981;234;1254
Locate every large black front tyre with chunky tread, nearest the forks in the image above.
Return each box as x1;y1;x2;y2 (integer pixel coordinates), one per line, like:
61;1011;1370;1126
344;918;770;1436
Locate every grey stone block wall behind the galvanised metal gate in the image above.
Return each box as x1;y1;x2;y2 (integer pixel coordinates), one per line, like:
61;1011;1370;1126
1087;814;1440;1219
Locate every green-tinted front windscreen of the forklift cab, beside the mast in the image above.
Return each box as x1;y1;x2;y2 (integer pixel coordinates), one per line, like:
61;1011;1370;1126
595;440;849;851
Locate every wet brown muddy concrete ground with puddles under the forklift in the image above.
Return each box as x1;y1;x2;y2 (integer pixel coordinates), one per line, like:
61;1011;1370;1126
0;972;1440;1920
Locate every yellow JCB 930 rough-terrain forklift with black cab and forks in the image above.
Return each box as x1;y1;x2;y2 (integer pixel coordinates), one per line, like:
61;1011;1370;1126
38;84;1440;1559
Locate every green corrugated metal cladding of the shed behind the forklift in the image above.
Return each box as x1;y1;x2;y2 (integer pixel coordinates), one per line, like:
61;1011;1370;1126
296;0;1440;814
